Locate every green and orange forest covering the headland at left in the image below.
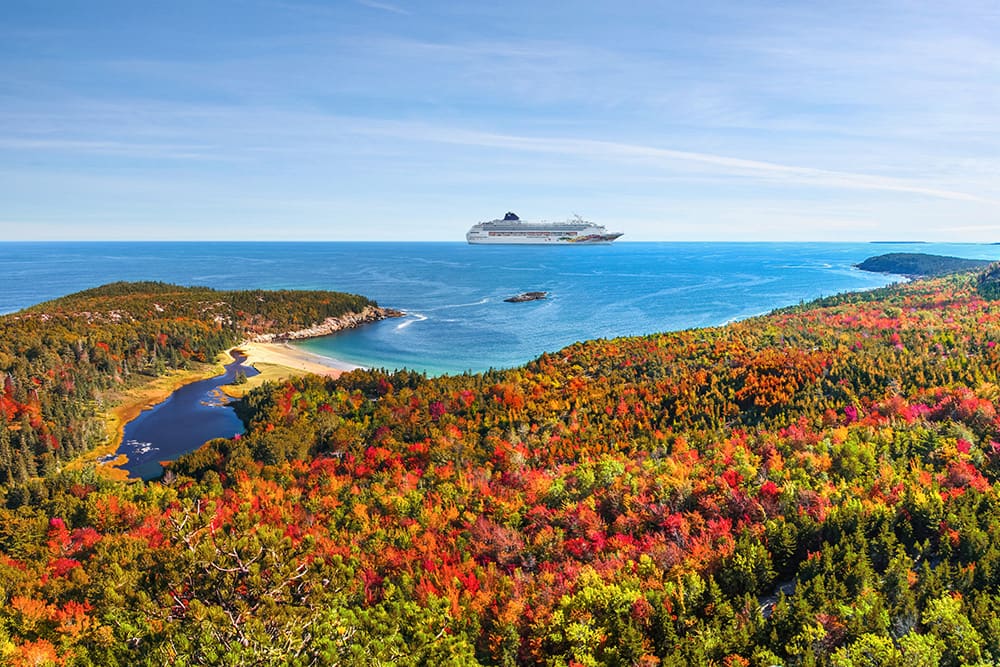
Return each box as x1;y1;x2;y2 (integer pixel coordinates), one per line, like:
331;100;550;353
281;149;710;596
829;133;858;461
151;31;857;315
0;282;372;485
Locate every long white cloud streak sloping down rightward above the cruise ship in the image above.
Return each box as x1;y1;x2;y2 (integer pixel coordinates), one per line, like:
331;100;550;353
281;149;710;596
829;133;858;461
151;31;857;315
0;99;1000;206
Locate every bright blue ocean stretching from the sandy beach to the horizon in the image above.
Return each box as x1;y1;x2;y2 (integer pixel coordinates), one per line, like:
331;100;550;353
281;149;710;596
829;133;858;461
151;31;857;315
0;242;1000;375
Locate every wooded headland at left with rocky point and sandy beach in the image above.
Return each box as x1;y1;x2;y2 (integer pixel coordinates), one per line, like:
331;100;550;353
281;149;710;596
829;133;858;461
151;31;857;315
0;281;397;482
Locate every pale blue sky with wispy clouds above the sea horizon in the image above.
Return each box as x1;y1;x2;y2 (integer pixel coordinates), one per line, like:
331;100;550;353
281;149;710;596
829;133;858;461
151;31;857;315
0;0;1000;242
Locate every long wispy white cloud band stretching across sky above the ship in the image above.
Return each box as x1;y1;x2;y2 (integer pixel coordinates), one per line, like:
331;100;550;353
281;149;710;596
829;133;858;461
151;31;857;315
0;94;1000;206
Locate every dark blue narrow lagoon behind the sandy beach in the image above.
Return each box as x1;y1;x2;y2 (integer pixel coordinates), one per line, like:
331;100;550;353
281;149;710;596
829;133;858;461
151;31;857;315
115;354;257;480
